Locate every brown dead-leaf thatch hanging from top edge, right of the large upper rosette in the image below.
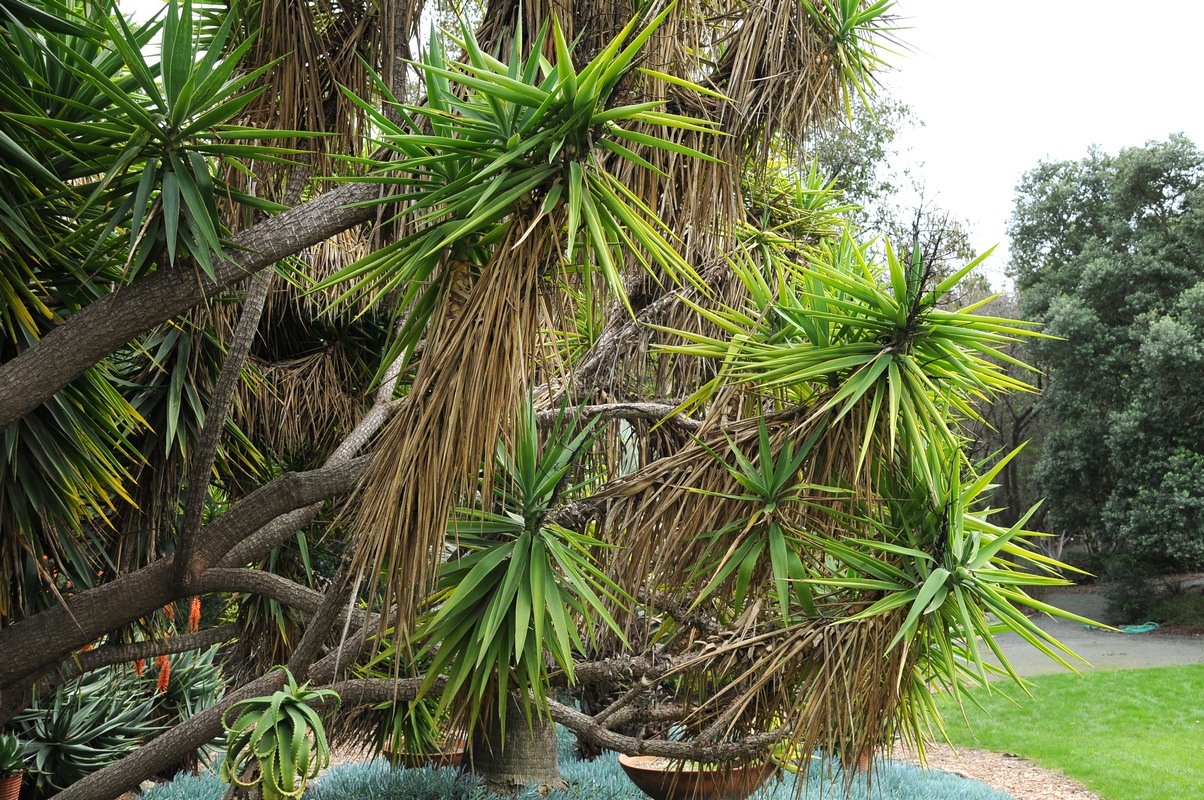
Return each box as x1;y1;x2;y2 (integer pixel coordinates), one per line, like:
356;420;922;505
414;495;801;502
577;0;905;396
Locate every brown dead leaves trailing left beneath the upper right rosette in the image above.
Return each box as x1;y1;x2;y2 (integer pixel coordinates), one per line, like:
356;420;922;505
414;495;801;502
602;394;890;593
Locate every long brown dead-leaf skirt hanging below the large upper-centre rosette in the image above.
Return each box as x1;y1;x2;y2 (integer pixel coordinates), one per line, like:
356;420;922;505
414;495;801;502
355;224;550;630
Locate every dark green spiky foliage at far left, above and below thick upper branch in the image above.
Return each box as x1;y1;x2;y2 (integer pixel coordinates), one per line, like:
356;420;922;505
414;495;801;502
0;1;290;616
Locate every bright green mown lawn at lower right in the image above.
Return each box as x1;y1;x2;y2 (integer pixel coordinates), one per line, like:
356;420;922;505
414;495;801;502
945;665;1204;800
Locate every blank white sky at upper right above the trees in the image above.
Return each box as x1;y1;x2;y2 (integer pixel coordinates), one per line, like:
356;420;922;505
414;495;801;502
884;0;1204;284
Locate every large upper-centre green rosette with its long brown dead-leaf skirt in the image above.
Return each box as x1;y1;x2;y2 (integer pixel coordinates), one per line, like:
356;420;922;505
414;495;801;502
318;4;713;645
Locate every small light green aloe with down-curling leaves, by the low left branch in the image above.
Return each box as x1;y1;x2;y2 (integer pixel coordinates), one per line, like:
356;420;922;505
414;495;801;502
222;666;338;800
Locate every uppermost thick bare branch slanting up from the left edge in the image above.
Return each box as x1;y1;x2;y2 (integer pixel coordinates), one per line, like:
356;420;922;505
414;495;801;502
0;183;379;428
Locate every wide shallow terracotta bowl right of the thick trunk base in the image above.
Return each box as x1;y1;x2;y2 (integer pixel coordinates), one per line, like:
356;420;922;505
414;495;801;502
619;754;778;800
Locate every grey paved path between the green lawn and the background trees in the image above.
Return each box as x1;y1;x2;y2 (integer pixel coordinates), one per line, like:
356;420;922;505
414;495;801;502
998;592;1204;677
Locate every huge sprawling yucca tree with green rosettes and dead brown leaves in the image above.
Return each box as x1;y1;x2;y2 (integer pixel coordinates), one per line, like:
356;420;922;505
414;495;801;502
0;0;1102;799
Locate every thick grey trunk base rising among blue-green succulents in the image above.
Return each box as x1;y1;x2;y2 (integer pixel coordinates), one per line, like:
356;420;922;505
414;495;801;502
465;699;568;795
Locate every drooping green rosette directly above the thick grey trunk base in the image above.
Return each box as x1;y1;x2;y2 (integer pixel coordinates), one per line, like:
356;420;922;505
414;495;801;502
415;404;630;725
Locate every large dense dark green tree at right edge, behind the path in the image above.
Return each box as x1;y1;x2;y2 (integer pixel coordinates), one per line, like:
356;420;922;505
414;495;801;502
1010;135;1204;569
